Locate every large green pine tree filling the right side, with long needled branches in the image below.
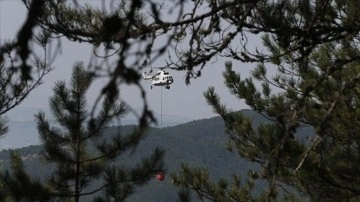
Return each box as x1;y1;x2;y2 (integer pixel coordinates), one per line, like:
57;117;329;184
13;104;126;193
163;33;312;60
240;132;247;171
173;1;360;201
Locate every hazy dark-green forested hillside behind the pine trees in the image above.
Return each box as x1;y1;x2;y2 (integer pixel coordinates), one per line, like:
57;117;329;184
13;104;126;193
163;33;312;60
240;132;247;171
0;110;265;202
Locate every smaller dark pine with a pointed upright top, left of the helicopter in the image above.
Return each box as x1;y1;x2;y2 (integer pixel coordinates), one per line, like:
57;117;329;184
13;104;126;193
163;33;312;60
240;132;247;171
2;63;163;201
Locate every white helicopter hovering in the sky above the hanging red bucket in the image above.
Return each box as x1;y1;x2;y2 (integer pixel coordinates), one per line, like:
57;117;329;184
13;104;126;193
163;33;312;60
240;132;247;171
142;69;174;89
